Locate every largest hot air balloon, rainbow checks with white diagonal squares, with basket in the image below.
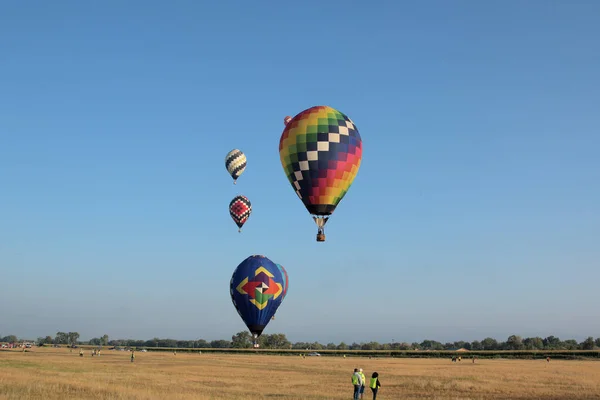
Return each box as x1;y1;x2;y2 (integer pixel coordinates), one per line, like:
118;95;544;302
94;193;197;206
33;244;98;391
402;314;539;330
279;106;362;242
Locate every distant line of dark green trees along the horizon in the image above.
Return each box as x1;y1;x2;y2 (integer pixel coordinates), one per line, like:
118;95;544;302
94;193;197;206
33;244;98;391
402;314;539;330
0;331;600;351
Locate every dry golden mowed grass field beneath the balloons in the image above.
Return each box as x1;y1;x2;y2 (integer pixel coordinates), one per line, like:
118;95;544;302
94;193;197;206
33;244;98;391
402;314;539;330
0;348;600;400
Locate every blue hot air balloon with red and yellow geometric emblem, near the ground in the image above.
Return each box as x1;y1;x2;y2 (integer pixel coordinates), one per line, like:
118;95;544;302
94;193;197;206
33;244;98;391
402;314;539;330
229;255;285;347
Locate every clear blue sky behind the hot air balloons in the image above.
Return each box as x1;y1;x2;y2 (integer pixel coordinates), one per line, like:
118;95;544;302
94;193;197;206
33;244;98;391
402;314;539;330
0;0;600;342
